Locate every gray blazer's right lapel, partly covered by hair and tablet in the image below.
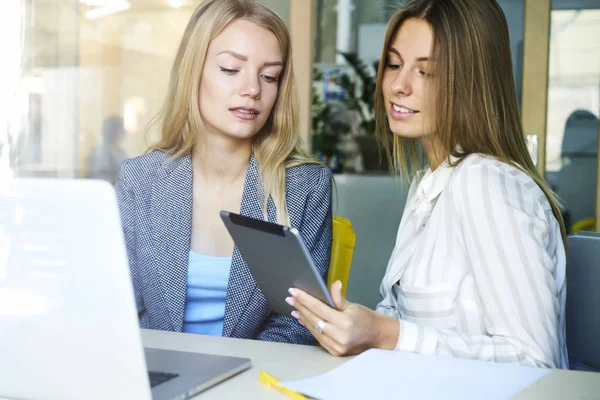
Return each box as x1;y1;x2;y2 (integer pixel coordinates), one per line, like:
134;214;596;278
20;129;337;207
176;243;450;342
223;156;277;336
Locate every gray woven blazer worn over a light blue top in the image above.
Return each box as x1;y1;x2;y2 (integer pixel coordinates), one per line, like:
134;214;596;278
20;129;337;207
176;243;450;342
116;151;332;344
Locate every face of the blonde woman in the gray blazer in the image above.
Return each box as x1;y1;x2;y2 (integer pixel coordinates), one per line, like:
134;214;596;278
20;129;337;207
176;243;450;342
199;19;283;144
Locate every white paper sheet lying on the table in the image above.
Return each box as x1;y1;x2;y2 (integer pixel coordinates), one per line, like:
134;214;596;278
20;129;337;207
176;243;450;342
282;350;550;400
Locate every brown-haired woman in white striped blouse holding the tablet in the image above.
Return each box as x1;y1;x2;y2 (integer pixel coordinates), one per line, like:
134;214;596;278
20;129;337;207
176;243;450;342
288;0;568;368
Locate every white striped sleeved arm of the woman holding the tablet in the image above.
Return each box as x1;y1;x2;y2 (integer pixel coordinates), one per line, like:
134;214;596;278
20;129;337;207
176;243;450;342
397;165;563;367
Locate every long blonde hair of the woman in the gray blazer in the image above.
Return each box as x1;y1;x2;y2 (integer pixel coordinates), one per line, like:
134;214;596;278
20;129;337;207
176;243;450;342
150;0;316;225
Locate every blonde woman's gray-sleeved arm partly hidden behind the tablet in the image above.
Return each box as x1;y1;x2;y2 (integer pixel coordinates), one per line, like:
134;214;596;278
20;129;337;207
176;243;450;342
258;168;332;344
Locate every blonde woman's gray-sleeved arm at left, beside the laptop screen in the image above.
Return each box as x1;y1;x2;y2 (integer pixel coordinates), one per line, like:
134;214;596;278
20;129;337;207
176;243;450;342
115;161;148;326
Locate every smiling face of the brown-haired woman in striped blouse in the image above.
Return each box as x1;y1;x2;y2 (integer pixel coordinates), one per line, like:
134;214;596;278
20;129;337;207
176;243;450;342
381;18;434;140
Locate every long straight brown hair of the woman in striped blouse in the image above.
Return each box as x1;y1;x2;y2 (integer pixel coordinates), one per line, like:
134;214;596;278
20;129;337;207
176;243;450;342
375;0;567;246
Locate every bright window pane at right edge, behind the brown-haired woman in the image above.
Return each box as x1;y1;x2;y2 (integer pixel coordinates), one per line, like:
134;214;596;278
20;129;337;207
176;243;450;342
546;7;600;228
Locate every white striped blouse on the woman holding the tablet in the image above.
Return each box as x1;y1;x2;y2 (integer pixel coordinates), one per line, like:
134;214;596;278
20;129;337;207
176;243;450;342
377;154;568;368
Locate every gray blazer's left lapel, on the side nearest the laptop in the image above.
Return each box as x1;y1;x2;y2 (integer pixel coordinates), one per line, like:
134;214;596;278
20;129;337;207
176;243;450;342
151;155;192;332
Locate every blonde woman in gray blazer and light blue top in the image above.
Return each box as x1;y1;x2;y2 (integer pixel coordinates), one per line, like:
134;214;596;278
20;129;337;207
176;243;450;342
116;0;331;344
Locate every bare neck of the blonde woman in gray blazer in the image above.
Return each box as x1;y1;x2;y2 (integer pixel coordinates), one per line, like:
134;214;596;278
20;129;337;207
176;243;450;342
192;135;252;185
